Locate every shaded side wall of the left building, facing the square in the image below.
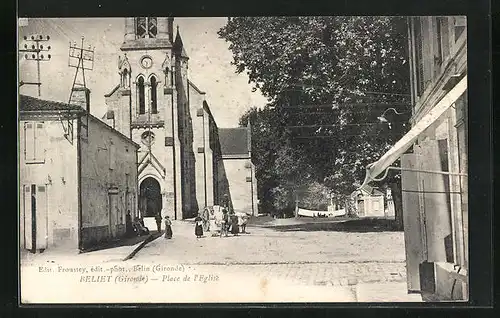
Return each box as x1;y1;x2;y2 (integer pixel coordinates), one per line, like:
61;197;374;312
81;117;137;248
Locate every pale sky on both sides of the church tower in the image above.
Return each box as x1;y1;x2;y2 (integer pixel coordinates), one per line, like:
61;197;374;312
18;17;266;128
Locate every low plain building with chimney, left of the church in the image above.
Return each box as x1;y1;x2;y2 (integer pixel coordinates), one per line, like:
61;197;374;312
19;90;139;251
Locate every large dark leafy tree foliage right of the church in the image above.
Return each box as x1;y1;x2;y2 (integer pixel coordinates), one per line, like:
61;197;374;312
223;17;410;226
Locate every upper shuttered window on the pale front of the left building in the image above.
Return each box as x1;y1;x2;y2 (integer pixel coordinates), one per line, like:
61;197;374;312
24;122;47;162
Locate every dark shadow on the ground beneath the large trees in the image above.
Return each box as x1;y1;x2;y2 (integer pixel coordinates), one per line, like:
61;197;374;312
252;218;400;233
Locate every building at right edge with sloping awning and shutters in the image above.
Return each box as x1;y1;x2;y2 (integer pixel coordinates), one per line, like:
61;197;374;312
363;16;469;300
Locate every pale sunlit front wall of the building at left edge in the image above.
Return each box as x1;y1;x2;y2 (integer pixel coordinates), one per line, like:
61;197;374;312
19;116;78;248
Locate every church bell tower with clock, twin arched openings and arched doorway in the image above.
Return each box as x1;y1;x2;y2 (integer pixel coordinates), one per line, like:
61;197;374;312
106;17;183;224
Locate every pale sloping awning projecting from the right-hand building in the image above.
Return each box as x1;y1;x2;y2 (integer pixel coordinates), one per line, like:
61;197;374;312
359;75;467;193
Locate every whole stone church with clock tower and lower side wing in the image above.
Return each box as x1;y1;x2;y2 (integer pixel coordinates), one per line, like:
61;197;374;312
103;17;257;228
